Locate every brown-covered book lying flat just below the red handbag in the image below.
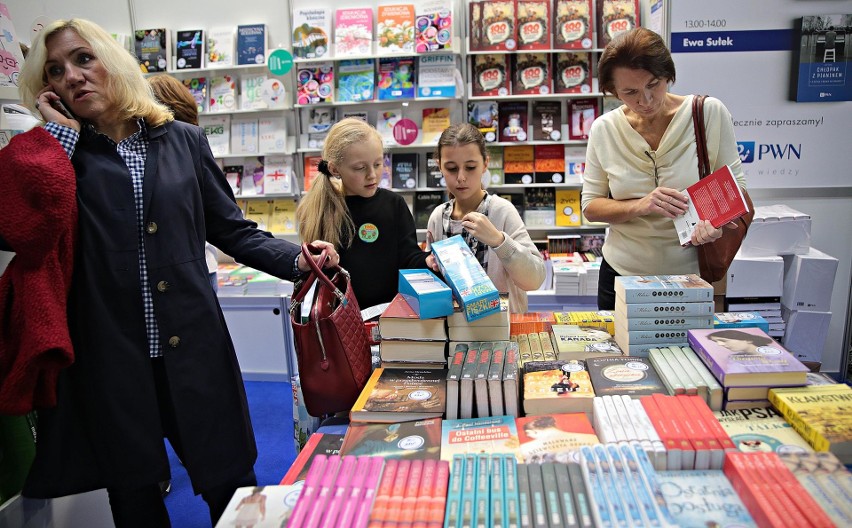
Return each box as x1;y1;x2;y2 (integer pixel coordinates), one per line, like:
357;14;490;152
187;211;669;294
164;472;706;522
350;369;447;422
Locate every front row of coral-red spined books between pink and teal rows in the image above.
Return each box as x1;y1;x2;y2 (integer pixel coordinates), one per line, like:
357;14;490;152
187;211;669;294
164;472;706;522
372;459;450;526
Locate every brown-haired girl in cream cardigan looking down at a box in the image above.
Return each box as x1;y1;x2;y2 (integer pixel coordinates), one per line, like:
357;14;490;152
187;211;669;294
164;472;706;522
428;123;545;313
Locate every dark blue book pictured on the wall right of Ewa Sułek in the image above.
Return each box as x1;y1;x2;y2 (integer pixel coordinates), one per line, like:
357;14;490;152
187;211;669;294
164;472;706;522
790;14;852;103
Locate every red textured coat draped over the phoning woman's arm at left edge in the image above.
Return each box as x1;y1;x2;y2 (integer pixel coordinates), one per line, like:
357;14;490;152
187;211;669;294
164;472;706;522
0;127;77;414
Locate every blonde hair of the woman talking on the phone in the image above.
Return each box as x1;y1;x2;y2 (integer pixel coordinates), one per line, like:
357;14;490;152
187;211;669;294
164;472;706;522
19;18;174;126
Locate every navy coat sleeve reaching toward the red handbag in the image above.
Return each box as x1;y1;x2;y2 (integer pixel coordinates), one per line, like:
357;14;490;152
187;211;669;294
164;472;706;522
196;128;300;280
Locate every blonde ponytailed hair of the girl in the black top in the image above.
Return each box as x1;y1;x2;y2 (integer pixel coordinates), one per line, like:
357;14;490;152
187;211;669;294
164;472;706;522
296;117;382;247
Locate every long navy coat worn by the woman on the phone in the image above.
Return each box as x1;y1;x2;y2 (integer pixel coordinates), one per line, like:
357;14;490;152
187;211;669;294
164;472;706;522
24;122;299;497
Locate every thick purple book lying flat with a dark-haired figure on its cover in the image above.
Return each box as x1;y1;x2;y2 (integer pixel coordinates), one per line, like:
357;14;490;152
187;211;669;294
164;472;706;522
688;328;808;387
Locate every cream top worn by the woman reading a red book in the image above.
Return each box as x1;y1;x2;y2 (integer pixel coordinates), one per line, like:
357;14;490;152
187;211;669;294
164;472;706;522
582;96;746;275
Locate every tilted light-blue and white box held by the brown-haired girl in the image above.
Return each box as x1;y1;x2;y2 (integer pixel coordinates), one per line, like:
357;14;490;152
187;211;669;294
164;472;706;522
432;235;500;322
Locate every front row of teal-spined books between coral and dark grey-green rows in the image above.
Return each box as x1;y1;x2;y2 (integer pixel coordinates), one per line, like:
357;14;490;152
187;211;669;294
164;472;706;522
442;453;523;526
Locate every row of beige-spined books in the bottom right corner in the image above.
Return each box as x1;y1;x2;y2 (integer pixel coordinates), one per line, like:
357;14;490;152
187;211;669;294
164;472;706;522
778;452;852;526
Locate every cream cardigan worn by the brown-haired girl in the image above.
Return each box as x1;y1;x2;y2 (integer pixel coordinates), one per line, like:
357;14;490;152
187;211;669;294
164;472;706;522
428;195;545;313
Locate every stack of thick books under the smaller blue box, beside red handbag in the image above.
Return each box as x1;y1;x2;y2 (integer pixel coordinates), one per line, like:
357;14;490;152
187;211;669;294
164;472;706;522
379;294;447;365
